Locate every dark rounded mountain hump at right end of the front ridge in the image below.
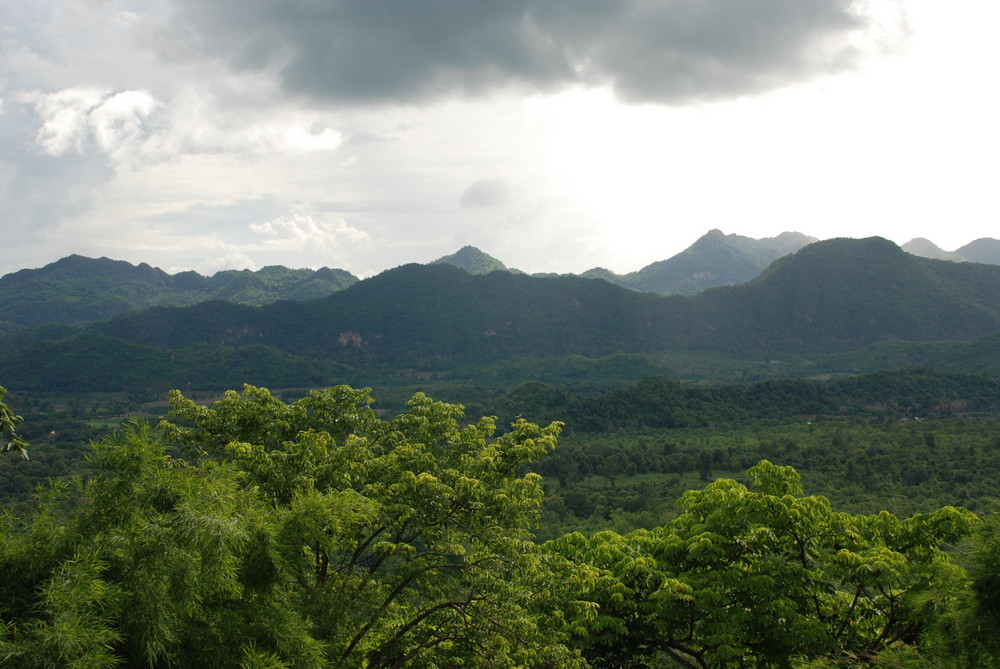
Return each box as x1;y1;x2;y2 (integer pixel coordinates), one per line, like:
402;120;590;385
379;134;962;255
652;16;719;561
694;237;1000;351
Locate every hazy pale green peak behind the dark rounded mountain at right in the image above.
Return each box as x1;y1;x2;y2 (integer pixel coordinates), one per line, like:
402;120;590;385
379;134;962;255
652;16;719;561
583;230;818;295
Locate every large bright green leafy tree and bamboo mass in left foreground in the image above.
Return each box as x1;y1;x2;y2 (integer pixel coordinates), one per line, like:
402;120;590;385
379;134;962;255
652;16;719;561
0;386;582;669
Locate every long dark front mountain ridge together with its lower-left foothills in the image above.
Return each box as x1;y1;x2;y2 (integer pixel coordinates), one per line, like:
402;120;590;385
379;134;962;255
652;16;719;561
0;237;1000;390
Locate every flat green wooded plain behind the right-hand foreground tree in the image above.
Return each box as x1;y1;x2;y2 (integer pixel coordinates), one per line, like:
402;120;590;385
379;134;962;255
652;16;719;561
533;416;1000;539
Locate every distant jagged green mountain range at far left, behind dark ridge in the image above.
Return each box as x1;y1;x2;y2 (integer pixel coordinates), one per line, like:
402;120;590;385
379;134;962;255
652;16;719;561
0;255;358;332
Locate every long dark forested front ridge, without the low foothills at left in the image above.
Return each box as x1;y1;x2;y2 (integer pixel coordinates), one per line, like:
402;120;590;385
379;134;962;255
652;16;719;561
94;238;1000;363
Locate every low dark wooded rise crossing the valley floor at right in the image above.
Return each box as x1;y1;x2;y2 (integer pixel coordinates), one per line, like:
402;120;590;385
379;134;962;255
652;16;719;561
492;369;1000;432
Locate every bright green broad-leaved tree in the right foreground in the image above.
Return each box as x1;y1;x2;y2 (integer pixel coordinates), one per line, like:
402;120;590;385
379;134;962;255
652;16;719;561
546;460;977;669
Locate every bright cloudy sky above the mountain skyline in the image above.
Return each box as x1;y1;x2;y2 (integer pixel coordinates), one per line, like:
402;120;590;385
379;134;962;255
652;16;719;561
0;0;1000;277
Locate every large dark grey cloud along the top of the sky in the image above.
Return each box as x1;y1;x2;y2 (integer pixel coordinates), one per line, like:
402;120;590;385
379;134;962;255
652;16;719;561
169;0;864;104
